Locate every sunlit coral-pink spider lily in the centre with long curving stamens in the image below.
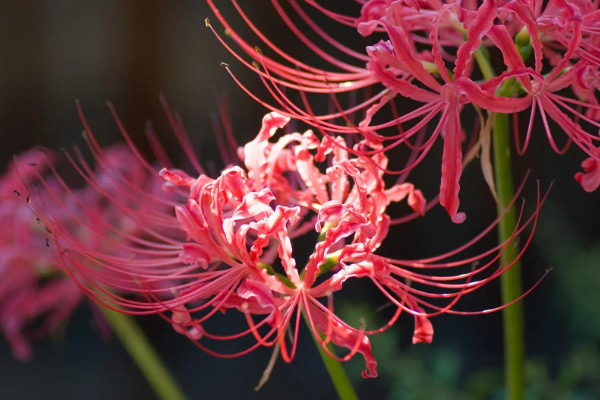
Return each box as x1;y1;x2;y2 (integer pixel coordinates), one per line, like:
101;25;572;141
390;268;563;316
30;104;540;377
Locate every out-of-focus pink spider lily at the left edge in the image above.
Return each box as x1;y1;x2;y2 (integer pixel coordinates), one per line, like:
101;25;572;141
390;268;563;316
0;145;155;360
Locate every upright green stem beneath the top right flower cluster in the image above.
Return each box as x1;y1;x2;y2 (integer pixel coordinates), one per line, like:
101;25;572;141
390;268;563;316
474;49;525;400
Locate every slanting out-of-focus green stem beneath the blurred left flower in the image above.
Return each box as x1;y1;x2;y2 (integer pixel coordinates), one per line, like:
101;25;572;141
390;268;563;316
100;307;187;400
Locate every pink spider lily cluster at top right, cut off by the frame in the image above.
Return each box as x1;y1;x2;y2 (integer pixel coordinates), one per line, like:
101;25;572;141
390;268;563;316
207;0;600;203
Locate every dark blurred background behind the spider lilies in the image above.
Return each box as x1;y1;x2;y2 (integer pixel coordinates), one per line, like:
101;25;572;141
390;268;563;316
0;0;600;400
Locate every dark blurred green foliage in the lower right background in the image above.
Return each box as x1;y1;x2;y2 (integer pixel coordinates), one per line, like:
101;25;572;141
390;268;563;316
336;203;600;400
